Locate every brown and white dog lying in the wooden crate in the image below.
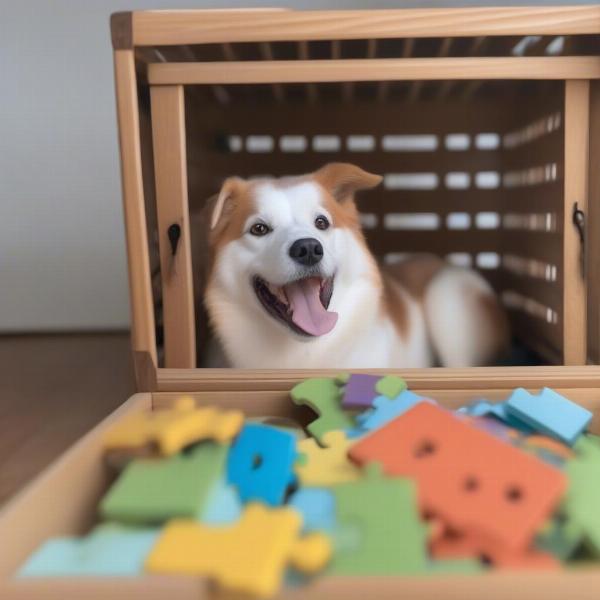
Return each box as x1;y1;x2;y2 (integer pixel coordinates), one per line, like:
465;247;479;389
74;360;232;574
205;163;508;368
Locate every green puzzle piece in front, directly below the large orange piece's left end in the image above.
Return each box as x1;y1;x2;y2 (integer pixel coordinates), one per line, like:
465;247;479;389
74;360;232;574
330;464;427;575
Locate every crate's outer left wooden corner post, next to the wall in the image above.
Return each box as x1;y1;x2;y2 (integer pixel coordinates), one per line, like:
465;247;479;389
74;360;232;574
114;50;157;382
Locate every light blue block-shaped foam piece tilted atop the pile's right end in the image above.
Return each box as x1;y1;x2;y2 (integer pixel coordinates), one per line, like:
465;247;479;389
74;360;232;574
506;388;592;446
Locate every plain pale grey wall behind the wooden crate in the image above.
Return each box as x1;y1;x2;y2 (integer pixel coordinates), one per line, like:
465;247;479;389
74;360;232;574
0;0;592;331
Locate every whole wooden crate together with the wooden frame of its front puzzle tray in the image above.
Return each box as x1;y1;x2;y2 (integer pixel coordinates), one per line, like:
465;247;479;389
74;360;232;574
0;6;600;600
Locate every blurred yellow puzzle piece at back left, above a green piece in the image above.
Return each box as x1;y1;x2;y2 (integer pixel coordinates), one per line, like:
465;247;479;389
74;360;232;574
104;396;244;456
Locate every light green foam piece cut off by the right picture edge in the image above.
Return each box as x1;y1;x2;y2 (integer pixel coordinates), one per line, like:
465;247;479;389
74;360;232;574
562;435;600;556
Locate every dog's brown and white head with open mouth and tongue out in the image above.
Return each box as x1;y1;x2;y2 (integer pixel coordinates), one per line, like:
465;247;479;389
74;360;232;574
209;163;381;337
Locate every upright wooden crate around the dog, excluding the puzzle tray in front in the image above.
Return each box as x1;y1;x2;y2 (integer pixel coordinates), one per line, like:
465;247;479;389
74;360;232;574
113;7;600;380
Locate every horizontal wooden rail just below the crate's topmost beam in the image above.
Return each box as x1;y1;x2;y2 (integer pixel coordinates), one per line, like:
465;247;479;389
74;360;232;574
148;56;600;85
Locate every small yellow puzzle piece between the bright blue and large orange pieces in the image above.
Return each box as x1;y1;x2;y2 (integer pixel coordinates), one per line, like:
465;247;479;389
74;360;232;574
295;431;361;486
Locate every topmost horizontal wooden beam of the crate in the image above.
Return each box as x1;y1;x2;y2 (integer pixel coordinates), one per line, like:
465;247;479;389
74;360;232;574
132;6;600;46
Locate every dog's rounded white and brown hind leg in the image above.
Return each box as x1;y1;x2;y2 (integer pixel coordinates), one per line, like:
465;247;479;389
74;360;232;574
424;267;509;368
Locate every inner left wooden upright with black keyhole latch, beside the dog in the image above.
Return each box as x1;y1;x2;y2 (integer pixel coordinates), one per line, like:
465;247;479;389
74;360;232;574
150;85;196;369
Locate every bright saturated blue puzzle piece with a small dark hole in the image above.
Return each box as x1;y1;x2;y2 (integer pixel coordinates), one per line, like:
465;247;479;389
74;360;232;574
227;423;297;506
